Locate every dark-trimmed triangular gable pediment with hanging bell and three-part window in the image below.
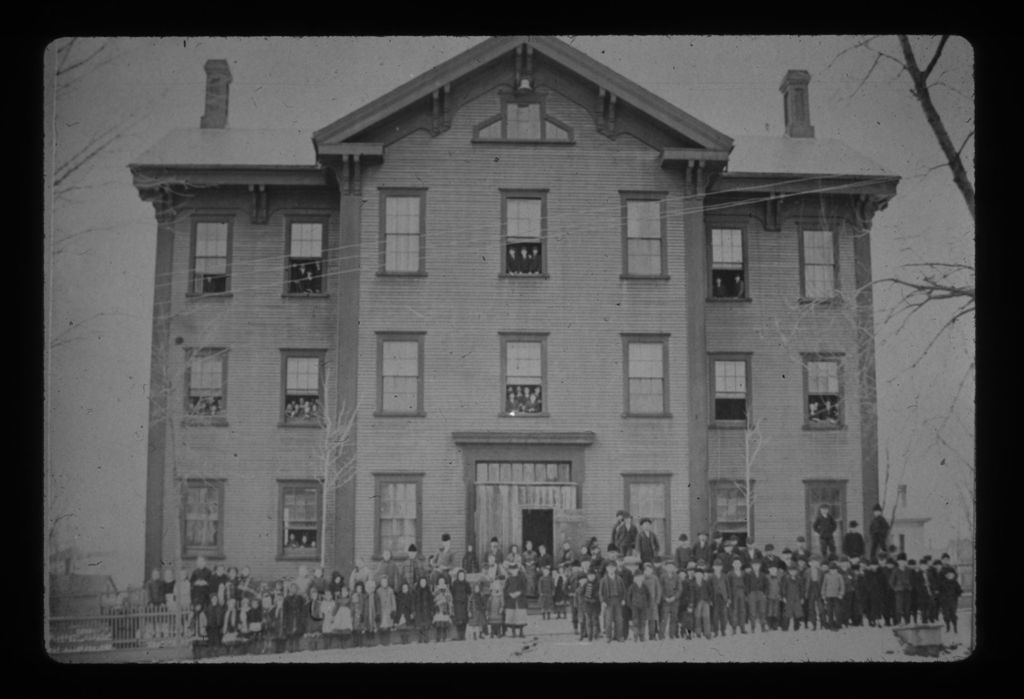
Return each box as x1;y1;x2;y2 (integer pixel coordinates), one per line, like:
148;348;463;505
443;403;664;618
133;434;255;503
313;37;732;152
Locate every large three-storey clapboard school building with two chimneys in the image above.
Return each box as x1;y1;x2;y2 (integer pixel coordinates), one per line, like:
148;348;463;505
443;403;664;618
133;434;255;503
130;37;898;577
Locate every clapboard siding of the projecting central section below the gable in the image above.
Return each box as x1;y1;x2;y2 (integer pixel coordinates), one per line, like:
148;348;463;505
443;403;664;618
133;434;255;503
356;69;688;555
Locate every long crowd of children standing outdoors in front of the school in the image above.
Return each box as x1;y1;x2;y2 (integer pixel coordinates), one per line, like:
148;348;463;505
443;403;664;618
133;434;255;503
140;508;962;650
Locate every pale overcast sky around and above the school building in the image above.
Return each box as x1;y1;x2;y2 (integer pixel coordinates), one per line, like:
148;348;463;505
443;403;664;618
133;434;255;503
45;36;974;584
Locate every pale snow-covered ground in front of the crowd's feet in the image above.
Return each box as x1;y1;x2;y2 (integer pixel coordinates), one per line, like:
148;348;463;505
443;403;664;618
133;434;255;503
186;610;970;663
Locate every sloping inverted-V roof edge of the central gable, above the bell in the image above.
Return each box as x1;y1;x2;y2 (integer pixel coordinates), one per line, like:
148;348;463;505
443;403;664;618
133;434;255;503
313;36;732;150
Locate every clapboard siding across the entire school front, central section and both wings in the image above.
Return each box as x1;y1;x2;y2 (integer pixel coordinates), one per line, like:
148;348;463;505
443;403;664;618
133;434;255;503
148;59;873;577
